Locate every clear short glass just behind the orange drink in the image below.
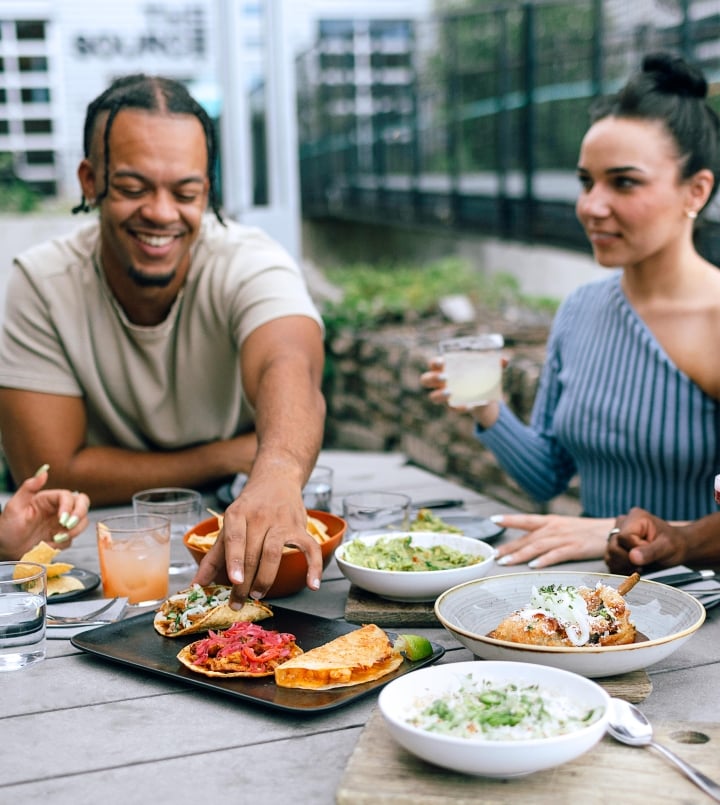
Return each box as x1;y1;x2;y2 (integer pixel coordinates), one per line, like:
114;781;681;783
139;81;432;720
133;486;203;576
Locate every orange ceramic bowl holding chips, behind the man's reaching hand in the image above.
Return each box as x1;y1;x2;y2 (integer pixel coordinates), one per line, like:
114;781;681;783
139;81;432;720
183;509;347;598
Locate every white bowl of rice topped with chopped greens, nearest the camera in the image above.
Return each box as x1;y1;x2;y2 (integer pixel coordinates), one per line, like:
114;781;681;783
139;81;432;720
378;662;610;778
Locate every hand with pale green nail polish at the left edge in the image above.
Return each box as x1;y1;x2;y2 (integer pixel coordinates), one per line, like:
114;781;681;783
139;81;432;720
0;472;90;560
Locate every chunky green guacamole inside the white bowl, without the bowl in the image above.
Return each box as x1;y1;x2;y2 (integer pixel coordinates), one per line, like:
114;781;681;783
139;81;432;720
344;536;485;571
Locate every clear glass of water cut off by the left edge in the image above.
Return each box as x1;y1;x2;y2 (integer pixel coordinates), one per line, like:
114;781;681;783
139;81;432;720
0;562;47;671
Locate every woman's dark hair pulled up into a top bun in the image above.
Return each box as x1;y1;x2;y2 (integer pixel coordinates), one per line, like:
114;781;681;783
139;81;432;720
590;53;720;207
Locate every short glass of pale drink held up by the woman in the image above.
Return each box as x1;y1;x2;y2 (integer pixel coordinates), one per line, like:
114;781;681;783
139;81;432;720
440;333;505;408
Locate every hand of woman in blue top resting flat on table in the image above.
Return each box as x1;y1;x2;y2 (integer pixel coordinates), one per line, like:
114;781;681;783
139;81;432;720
492;514;615;569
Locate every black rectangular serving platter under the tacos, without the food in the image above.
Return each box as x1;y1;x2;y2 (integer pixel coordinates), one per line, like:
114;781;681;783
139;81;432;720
71;606;445;713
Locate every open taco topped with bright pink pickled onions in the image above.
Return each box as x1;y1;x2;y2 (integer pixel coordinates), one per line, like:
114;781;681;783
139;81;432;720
177;623;302;678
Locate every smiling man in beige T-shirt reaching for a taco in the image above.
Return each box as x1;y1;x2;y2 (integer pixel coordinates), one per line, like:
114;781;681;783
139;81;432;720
0;75;325;601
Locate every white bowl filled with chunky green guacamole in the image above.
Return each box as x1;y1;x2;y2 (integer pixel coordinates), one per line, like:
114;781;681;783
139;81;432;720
335;531;495;601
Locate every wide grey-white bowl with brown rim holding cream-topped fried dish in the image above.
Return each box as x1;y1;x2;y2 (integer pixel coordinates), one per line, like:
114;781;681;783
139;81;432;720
434;569;705;678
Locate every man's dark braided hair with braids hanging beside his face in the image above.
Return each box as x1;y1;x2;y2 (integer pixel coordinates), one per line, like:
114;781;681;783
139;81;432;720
72;73;224;224
